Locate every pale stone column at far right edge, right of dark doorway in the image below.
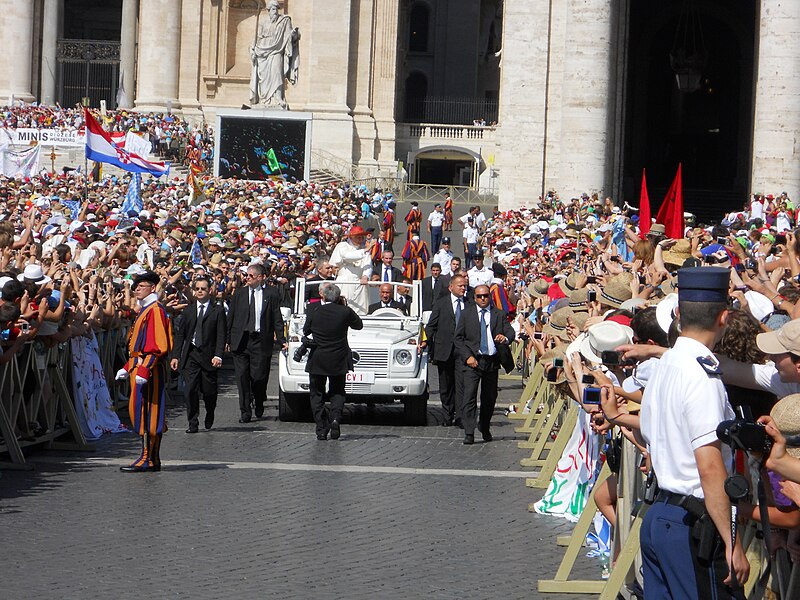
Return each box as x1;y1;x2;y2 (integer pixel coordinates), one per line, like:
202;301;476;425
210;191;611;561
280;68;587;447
751;0;800;196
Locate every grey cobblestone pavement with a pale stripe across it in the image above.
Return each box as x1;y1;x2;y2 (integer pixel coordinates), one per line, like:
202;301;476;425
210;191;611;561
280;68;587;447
0;371;599;600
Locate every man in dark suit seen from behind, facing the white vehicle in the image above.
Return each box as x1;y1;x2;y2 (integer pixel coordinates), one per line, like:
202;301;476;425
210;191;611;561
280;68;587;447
303;282;364;440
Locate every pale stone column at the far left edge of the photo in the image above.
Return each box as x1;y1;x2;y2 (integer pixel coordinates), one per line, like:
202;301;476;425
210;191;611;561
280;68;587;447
0;0;34;104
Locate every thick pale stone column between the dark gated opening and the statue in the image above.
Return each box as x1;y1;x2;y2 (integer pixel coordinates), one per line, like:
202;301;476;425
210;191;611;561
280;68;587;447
135;0;181;110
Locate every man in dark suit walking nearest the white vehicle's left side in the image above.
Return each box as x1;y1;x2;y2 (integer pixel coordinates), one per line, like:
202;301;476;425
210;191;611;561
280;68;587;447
227;263;287;423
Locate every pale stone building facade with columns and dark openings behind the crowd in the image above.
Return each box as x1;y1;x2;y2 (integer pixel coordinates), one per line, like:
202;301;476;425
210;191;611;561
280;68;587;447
0;0;800;213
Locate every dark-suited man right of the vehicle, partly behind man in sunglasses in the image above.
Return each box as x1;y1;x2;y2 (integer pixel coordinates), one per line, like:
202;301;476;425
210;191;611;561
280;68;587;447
425;275;467;427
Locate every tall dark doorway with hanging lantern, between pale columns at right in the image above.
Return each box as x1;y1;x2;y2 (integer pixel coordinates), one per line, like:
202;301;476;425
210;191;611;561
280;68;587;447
624;0;756;217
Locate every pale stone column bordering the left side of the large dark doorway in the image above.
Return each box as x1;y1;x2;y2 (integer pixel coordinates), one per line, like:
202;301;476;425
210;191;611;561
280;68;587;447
556;0;614;198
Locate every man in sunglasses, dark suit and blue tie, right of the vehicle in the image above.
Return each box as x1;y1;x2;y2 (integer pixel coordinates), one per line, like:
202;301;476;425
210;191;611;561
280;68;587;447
455;285;514;444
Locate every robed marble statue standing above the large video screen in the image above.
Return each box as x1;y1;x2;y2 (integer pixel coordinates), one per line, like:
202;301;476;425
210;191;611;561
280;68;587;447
250;0;300;110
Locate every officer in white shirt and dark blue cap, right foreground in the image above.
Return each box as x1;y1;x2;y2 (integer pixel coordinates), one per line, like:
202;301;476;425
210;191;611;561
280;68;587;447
641;267;750;600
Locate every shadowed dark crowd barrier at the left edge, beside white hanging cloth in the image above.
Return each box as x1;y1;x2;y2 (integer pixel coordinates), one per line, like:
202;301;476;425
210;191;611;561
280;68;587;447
0;341;91;469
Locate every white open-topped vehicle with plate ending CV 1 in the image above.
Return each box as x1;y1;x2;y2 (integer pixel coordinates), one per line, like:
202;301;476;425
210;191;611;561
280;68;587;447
278;279;428;425
